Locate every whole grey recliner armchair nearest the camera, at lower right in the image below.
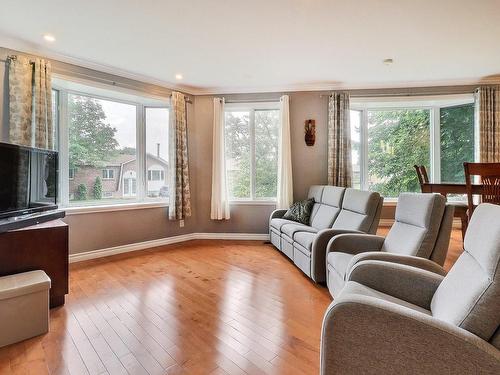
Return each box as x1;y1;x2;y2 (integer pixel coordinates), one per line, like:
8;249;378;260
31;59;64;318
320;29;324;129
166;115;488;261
320;204;500;375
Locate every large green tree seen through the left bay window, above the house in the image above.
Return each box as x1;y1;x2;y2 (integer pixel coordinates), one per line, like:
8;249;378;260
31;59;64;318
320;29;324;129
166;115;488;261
68;95;118;168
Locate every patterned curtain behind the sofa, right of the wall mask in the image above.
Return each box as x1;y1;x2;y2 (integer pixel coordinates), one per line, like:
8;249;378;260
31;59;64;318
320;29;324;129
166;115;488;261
328;92;352;187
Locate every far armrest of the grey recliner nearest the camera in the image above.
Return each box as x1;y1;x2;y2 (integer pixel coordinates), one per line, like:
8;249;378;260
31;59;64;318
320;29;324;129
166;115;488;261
346;260;444;310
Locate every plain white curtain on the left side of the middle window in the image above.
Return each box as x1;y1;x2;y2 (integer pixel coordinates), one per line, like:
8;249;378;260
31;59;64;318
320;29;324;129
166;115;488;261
210;98;230;220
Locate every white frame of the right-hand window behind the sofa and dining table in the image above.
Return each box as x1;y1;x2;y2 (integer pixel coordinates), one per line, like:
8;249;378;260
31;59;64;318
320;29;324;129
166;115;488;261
350;93;479;202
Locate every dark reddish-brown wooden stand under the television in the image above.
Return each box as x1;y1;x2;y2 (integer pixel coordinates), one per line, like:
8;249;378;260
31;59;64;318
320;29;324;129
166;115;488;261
0;219;69;308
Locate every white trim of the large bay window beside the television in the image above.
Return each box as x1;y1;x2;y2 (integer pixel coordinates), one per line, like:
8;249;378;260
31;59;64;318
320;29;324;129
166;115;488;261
52;74;170;215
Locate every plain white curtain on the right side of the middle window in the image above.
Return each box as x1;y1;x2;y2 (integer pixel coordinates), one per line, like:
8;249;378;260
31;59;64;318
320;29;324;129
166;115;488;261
276;95;293;209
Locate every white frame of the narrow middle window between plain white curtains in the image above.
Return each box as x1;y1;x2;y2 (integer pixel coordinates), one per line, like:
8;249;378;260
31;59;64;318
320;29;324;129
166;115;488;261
224;100;281;205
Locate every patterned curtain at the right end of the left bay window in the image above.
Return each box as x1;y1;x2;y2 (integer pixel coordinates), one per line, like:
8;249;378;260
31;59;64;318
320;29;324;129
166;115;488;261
168;92;191;220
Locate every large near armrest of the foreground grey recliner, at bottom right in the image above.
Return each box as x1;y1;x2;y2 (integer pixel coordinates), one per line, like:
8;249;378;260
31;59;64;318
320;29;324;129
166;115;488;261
320;294;500;375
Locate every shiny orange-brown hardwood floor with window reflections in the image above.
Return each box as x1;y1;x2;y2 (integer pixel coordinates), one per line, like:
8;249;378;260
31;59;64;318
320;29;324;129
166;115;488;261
0;229;462;375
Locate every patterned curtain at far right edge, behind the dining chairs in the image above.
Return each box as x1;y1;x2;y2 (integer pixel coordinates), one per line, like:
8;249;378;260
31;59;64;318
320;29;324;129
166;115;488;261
477;86;500;163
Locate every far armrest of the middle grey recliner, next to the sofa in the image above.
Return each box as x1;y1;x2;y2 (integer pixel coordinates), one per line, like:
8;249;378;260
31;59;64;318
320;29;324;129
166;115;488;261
326;234;385;254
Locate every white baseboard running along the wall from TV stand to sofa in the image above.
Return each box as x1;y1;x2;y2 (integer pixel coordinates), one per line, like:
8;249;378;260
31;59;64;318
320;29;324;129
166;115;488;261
69;233;269;263
